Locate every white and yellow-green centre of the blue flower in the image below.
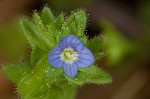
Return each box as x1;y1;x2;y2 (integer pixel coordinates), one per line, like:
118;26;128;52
60;47;78;64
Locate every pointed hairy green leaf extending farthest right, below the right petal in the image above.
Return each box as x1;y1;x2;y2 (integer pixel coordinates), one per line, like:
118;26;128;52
79;65;112;84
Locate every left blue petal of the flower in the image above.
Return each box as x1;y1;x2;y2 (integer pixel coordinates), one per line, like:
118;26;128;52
48;47;62;68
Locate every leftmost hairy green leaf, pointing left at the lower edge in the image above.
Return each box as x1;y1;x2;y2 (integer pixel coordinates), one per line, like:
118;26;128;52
3;64;30;84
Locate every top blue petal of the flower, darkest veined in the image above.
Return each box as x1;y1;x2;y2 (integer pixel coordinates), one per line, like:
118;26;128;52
58;35;83;51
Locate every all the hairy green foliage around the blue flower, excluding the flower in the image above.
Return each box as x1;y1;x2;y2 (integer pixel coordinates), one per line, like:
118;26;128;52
3;7;111;99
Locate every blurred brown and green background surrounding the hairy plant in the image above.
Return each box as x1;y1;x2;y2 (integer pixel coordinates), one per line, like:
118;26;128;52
0;0;150;99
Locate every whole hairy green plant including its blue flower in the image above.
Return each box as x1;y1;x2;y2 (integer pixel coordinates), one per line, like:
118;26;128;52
3;7;112;99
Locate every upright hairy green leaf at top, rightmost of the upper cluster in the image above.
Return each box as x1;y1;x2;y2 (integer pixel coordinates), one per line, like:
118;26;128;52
62;10;87;37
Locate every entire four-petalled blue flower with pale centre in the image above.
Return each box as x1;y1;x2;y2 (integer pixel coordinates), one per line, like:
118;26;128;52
48;35;94;78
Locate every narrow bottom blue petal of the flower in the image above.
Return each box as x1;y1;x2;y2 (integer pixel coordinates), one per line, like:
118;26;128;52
63;63;78;78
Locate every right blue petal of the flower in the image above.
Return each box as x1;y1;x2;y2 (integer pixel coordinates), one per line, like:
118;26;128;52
75;47;94;68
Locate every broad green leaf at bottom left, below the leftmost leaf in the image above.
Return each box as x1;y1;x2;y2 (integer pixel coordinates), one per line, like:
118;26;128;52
17;73;48;98
